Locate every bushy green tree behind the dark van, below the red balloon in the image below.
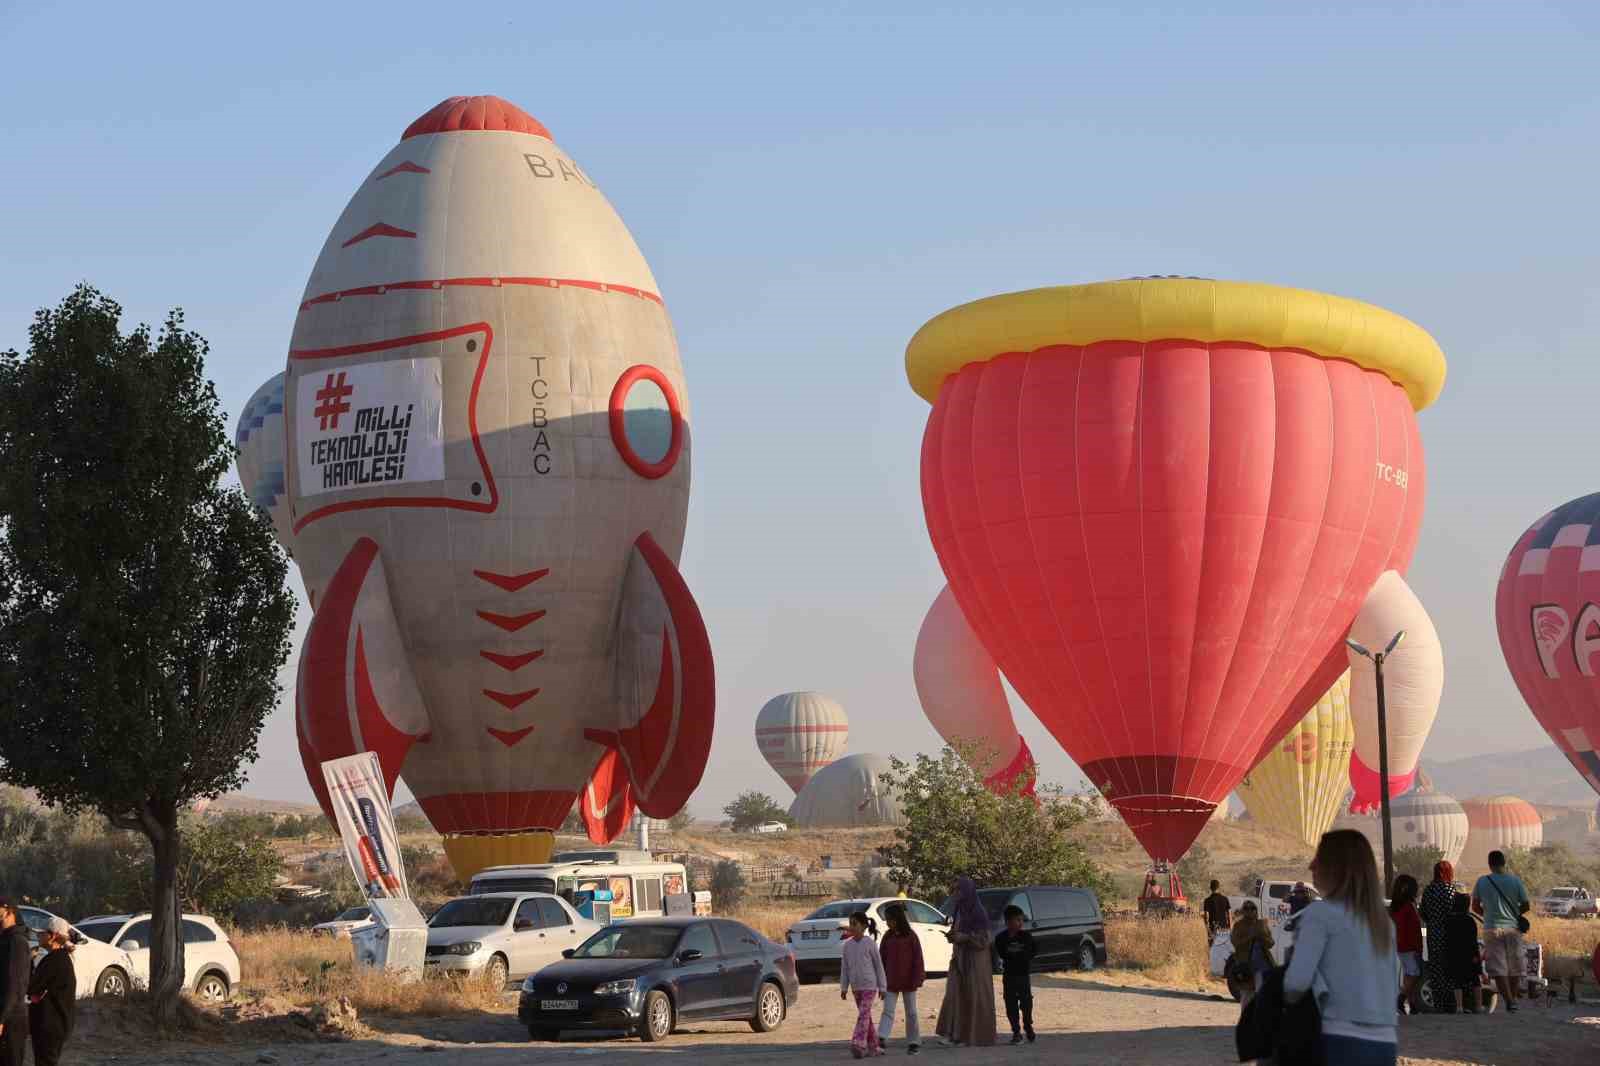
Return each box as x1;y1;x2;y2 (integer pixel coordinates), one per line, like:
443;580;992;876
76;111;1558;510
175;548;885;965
880;747;1110;900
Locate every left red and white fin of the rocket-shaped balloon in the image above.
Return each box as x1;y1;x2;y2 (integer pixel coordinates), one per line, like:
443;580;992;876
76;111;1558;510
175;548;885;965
294;536;429;820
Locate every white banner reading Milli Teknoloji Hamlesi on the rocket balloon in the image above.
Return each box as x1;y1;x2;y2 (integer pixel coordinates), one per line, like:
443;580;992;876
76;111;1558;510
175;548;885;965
296;359;445;496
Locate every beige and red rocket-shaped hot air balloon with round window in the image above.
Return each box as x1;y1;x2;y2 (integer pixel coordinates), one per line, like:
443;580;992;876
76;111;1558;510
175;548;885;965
240;96;714;877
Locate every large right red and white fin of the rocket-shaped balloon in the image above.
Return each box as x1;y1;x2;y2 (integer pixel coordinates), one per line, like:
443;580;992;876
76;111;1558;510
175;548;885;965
586;533;717;818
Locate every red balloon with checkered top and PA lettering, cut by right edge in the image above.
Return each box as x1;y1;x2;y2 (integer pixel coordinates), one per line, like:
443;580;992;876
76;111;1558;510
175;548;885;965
1494;493;1600;792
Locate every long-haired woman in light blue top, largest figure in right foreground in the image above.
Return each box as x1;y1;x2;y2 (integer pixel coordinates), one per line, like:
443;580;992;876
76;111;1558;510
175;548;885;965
1283;829;1400;1066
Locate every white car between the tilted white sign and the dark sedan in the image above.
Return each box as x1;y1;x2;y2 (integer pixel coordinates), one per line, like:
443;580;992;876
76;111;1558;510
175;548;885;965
424;892;602;988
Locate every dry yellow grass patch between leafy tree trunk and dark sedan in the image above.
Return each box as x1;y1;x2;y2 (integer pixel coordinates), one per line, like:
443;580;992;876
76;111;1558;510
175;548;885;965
234;928;502;1015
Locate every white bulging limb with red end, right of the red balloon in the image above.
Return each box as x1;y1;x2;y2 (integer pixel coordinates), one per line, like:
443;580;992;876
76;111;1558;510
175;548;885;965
1347;570;1445;812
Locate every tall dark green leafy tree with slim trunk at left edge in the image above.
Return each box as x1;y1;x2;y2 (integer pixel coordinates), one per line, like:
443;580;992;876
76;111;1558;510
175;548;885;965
0;285;294;1024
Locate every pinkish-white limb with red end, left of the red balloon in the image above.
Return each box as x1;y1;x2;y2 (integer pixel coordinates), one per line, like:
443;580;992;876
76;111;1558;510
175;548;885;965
912;586;1037;791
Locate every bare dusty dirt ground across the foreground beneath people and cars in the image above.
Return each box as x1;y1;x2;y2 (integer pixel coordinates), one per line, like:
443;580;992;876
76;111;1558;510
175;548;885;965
69;973;1600;1066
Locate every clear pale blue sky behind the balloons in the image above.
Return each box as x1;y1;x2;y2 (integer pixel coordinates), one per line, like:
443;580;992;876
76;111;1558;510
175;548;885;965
0;0;1600;815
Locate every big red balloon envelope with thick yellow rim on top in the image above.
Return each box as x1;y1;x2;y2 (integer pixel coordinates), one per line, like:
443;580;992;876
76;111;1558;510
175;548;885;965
906;279;1445;861
